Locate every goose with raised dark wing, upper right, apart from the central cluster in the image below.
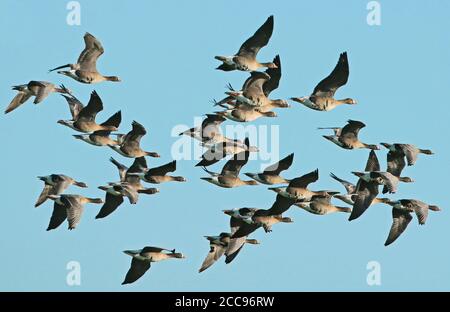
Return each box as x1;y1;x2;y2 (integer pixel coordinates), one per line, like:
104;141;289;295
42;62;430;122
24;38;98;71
291;52;357;111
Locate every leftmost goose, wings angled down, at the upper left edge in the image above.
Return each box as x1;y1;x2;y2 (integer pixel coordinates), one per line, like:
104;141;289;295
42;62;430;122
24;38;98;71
5;80;72;114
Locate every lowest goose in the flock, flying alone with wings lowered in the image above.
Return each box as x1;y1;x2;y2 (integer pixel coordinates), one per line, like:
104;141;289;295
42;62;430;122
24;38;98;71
122;246;186;285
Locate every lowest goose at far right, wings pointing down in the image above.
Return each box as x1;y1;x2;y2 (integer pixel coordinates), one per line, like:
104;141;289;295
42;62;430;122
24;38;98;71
384;199;441;246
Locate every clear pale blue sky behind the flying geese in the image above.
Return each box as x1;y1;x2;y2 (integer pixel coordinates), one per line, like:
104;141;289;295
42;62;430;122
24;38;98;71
0;0;450;291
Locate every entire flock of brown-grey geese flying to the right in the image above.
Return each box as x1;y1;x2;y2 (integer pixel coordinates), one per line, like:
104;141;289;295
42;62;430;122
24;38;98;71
5;16;440;284
